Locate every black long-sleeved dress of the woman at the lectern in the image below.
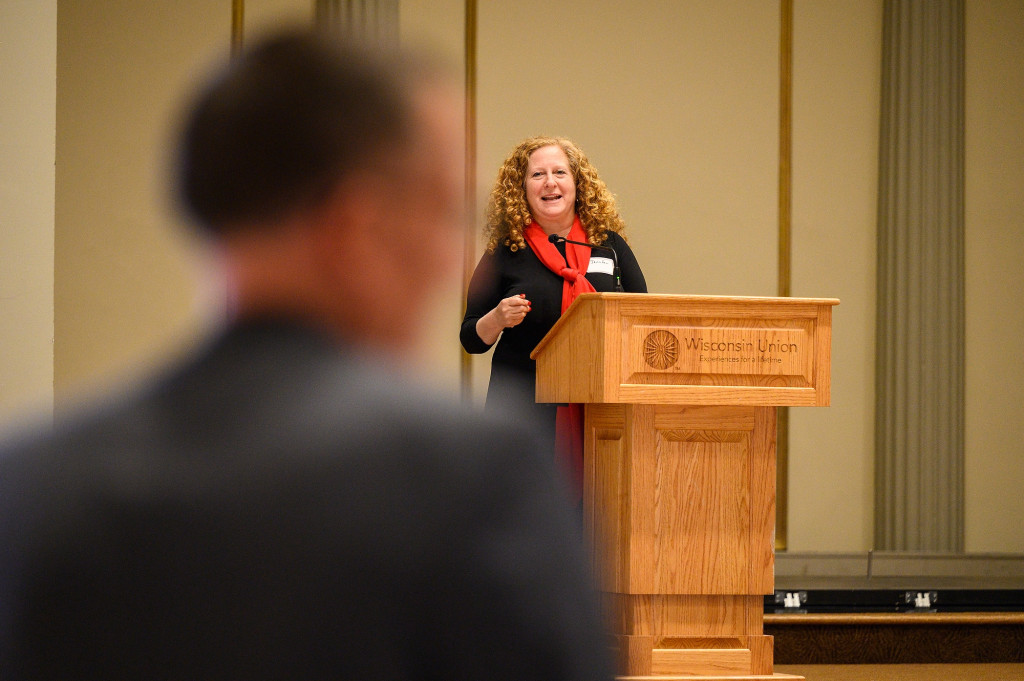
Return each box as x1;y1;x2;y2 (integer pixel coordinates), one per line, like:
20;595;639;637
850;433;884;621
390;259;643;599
460;231;647;430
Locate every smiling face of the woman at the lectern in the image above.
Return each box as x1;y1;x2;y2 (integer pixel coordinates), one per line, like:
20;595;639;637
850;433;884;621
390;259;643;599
523;144;575;235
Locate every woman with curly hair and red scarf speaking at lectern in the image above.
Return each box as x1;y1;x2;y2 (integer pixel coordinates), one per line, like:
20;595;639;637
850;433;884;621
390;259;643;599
460;137;647;501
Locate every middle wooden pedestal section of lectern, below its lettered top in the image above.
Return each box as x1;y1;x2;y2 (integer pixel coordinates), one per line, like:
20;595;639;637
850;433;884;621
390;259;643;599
585;405;775;595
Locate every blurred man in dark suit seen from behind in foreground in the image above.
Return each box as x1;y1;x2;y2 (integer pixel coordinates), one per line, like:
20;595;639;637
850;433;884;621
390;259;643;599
0;27;608;681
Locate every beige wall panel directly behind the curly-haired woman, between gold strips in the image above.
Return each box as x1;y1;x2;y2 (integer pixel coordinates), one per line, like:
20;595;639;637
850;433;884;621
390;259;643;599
474;0;779;401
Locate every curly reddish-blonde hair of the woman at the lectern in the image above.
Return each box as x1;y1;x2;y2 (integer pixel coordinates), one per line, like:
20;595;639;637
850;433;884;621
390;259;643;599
483;137;626;253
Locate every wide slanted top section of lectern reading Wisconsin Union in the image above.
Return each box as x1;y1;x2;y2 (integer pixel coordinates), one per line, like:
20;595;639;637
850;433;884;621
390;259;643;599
530;293;839;407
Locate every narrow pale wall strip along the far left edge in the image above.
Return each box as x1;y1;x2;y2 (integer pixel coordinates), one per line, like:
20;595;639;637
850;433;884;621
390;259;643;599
0;0;57;421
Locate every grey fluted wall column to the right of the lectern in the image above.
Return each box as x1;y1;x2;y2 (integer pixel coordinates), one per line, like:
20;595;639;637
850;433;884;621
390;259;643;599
874;0;965;552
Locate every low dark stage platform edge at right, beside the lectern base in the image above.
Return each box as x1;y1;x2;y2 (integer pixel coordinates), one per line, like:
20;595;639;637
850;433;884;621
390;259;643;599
764;554;1024;665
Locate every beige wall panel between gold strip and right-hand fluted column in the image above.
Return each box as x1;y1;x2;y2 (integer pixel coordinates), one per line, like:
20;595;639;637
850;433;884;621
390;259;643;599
788;0;882;551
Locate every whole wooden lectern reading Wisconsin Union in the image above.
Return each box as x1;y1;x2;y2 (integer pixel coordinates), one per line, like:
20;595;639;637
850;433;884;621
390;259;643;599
531;293;839;681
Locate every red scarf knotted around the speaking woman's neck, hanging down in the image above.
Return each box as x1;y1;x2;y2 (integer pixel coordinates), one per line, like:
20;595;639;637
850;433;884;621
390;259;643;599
523;217;594;504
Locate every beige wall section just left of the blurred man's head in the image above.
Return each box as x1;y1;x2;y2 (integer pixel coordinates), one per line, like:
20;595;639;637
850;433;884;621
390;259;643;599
54;0;230;396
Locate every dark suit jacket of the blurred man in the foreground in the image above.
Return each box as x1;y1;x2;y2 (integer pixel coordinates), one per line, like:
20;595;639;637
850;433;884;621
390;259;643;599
0;324;608;681
